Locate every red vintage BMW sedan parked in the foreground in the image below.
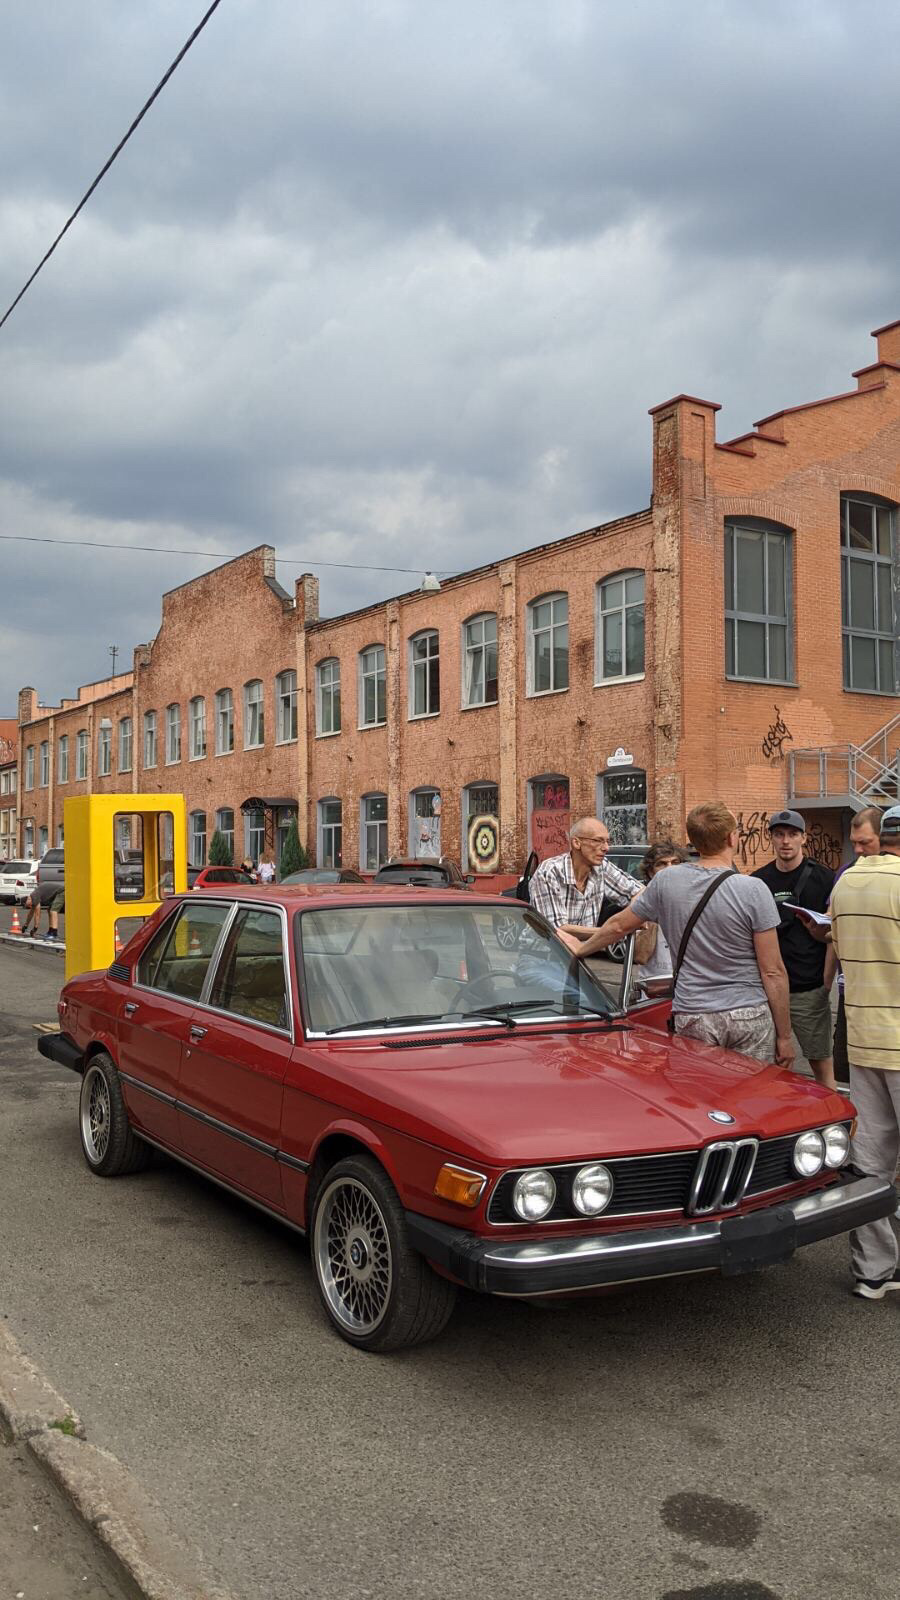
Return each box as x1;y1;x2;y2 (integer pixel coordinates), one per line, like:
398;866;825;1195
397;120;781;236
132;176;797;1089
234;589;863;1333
38;885;897;1350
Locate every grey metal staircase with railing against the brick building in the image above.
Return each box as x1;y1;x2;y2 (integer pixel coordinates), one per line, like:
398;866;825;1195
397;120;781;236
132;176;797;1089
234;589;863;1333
788;714;900;811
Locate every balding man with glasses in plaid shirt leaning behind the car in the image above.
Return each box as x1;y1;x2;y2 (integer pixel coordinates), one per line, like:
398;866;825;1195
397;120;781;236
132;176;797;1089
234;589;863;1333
528;816;644;928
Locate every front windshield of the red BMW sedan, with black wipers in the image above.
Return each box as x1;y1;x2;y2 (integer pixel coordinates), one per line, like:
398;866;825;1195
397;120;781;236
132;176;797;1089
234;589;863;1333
296;902;613;1034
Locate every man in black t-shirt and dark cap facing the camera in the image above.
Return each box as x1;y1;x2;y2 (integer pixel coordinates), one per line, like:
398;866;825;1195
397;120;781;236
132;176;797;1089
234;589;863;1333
753;811;834;1088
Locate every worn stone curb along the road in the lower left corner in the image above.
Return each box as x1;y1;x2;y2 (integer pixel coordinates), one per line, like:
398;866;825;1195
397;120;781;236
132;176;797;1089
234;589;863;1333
0;1328;232;1600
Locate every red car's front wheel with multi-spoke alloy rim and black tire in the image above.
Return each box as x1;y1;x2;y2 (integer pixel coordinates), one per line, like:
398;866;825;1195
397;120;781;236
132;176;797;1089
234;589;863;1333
312;1155;456;1350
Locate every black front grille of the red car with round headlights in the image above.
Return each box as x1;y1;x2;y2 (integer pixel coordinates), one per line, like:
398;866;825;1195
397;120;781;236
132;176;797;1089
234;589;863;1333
487;1133;830;1226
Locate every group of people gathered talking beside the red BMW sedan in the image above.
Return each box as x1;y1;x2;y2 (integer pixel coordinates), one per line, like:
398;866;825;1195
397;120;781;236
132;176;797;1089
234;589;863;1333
528;800;900;1299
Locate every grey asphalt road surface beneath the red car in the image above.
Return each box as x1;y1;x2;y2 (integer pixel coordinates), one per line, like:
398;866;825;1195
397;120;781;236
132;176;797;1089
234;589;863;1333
0;946;900;1600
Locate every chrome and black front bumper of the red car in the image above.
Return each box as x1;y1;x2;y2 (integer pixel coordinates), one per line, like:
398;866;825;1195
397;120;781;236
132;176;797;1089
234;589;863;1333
407;1178;897;1296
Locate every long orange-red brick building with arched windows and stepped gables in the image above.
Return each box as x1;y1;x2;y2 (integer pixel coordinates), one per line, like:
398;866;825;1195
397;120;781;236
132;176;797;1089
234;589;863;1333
18;323;900;870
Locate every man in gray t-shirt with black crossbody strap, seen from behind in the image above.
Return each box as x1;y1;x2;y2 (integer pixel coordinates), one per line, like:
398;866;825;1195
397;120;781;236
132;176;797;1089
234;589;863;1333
559;800;794;1067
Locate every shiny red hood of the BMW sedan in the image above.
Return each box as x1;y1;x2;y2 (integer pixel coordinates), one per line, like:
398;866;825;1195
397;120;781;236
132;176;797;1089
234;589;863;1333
301;1027;849;1165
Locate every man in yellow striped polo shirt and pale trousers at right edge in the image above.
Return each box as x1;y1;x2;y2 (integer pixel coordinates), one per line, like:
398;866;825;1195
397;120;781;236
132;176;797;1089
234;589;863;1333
831;806;900;1299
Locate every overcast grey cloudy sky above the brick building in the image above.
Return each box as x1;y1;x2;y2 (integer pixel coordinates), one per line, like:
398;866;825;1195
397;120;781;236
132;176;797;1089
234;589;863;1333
0;0;900;715
